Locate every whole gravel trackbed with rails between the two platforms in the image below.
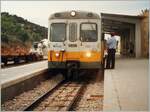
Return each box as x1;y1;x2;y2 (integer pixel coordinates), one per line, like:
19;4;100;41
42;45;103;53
2;70;103;111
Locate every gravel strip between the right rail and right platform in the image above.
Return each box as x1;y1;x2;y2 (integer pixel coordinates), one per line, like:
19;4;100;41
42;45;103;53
73;70;104;111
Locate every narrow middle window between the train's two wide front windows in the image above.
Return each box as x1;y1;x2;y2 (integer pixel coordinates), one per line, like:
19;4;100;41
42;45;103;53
69;23;77;42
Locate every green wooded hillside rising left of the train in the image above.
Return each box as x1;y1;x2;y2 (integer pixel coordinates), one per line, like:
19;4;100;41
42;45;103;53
1;12;47;47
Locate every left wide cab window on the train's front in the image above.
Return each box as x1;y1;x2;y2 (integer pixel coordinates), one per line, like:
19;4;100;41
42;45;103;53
50;23;66;42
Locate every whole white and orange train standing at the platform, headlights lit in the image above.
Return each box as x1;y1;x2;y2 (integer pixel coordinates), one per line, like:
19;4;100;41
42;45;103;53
48;11;104;77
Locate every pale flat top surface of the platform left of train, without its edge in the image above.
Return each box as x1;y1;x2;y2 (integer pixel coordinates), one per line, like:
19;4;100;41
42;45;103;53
0;61;48;84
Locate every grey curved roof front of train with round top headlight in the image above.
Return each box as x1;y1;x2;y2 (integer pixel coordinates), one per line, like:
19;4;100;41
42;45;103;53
49;11;100;20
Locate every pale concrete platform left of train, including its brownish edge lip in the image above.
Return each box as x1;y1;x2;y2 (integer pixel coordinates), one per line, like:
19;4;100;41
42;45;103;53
0;61;48;88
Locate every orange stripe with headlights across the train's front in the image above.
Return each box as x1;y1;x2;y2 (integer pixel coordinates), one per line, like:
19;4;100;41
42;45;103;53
48;51;102;62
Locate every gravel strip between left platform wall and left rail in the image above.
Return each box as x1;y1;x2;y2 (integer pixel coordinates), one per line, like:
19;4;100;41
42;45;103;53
1;75;63;111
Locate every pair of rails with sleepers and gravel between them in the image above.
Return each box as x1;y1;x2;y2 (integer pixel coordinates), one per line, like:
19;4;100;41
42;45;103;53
24;82;85;111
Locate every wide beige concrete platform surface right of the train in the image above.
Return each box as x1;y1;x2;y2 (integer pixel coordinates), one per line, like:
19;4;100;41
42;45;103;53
103;59;149;111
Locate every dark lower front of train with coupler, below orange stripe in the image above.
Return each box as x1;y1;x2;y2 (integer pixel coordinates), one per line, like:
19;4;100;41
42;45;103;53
48;60;104;80
